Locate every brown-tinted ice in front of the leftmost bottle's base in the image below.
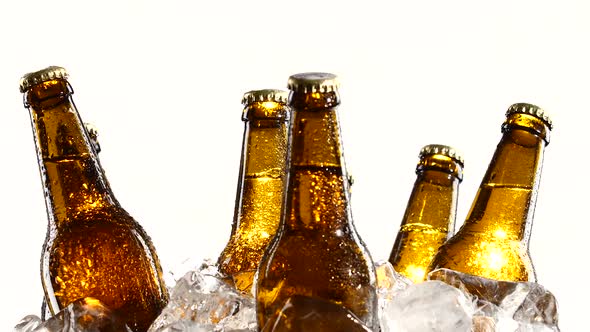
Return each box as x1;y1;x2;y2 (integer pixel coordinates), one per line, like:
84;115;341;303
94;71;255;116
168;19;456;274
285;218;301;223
15;297;131;332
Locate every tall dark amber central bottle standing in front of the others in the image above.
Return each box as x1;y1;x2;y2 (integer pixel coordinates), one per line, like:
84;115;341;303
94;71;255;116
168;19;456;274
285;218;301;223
256;73;378;329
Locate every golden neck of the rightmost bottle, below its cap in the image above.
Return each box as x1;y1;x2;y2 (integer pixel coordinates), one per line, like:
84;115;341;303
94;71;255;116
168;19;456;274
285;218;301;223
465;124;547;244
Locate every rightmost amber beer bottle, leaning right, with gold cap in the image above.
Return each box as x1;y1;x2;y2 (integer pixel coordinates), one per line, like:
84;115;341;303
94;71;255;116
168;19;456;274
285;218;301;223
430;103;552;281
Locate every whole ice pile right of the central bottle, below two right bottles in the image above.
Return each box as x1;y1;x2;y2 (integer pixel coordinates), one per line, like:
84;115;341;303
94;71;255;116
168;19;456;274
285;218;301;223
377;262;559;332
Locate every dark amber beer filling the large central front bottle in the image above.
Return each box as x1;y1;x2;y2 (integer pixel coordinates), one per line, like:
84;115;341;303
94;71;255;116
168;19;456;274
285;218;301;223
257;167;375;324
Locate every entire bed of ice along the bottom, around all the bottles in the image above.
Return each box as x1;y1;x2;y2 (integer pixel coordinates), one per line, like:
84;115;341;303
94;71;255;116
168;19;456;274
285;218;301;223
15;261;559;332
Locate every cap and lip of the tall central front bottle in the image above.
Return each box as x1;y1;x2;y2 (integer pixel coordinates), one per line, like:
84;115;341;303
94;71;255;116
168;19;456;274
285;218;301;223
287;72;340;111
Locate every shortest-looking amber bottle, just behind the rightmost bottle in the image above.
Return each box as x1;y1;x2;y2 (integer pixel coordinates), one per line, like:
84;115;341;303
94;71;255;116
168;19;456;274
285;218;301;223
389;144;464;283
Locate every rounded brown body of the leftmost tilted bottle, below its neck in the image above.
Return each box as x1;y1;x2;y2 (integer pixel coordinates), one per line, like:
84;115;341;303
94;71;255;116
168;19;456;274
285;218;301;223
41;209;168;331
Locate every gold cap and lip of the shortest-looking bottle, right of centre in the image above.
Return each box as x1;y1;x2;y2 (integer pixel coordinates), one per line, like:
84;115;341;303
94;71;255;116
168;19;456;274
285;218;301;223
416;144;465;181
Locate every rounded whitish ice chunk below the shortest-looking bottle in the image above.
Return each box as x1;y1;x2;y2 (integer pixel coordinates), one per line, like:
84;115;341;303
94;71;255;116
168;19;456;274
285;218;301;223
381;281;476;332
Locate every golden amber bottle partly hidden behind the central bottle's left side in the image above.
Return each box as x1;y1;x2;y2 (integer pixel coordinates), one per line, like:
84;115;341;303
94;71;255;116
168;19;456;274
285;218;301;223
217;90;290;293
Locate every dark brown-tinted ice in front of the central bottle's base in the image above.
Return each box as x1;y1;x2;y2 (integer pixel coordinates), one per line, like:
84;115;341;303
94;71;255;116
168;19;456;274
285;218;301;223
262;295;371;332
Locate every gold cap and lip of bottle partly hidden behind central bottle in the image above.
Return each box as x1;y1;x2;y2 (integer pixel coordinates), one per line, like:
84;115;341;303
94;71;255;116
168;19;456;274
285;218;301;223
242;89;290;121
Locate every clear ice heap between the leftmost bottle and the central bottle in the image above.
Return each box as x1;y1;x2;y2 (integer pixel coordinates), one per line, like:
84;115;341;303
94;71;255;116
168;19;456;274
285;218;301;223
149;261;256;332
